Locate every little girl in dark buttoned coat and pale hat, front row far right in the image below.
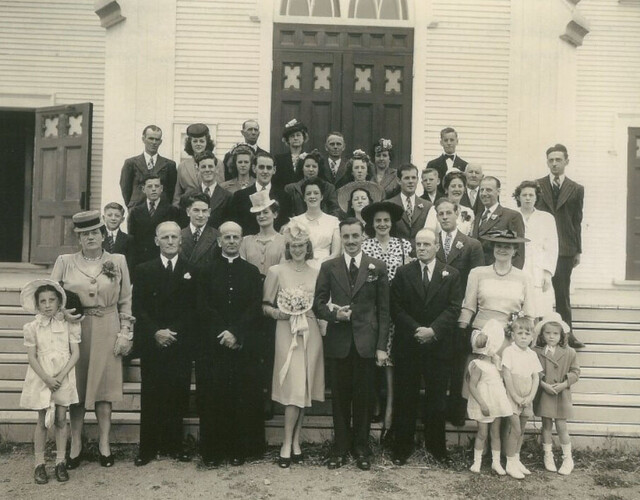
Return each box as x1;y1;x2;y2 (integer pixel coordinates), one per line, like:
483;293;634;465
533;312;580;476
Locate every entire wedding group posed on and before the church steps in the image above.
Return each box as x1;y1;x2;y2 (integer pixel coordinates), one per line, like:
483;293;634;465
21;120;583;483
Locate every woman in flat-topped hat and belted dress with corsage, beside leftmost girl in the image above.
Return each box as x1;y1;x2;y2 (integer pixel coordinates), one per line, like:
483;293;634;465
51;210;135;469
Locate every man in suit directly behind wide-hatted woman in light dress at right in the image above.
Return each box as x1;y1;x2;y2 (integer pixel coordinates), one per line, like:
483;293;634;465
472;176;524;269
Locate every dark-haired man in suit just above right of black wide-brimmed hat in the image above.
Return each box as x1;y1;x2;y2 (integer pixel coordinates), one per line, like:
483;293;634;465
389;163;431;251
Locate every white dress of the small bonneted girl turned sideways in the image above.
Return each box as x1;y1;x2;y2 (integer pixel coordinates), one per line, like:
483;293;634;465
467;359;513;424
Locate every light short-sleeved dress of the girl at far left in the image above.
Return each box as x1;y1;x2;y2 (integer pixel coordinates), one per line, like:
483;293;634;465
20;314;80;410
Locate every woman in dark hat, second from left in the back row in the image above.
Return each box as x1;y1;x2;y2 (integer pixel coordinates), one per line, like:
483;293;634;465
172;123;224;207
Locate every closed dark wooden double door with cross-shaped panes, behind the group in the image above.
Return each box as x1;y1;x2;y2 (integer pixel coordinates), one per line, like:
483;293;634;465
271;24;413;165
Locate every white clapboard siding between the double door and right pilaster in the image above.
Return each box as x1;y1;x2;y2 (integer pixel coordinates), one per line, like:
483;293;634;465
416;0;511;178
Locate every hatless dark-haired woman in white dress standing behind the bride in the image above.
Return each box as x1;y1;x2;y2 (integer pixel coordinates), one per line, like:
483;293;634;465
291;177;341;269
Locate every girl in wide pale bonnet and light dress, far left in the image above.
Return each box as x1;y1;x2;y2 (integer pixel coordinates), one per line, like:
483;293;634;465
20;279;80;484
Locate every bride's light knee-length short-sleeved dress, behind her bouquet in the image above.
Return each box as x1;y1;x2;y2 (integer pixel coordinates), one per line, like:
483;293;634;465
263;262;324;408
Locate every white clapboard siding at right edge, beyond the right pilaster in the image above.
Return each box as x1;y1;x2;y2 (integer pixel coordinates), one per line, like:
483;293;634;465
567;0;640;287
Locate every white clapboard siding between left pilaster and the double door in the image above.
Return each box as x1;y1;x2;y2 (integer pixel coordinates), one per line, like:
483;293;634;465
174;0;268;156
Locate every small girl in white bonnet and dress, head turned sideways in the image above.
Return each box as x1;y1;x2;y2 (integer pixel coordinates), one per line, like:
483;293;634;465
467;320;513;476
